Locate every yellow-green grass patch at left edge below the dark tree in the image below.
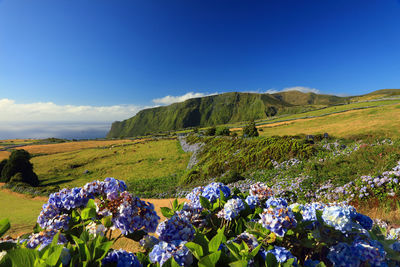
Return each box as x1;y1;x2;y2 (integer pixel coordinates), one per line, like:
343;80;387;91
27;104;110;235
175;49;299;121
0;191;45;235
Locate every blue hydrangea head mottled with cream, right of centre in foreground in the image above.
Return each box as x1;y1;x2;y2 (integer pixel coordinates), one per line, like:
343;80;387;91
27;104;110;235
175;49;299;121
259;207;297;237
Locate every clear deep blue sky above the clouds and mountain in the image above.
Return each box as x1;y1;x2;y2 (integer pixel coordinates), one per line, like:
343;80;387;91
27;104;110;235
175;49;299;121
0;0;400;105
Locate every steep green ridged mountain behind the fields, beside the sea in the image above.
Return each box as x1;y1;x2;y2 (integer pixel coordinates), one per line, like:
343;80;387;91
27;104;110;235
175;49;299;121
107;91;350;138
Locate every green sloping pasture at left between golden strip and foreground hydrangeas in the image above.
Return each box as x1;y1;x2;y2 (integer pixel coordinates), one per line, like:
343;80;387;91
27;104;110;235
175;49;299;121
31;140;190;191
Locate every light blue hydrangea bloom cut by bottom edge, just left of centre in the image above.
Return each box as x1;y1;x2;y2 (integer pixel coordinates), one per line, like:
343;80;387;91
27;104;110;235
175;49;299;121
149;240;193;266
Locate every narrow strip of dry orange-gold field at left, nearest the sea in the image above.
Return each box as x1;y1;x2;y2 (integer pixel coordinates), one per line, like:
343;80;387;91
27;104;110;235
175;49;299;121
21;140;140;154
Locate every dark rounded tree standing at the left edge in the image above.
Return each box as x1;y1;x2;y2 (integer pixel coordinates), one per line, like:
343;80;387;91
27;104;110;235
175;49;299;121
1;149;39;186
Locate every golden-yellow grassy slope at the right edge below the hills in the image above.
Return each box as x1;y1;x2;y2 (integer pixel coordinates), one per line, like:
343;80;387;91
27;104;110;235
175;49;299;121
260;104;400;137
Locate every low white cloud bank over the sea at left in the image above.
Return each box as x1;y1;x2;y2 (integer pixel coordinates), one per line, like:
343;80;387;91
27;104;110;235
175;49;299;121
0;98;145;122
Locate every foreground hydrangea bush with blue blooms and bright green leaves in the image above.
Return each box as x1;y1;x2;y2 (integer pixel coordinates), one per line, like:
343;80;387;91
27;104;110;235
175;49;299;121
0;178;400;266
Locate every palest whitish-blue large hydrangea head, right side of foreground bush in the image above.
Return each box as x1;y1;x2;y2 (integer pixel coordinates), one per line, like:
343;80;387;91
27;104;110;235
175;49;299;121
322;206;357;233
